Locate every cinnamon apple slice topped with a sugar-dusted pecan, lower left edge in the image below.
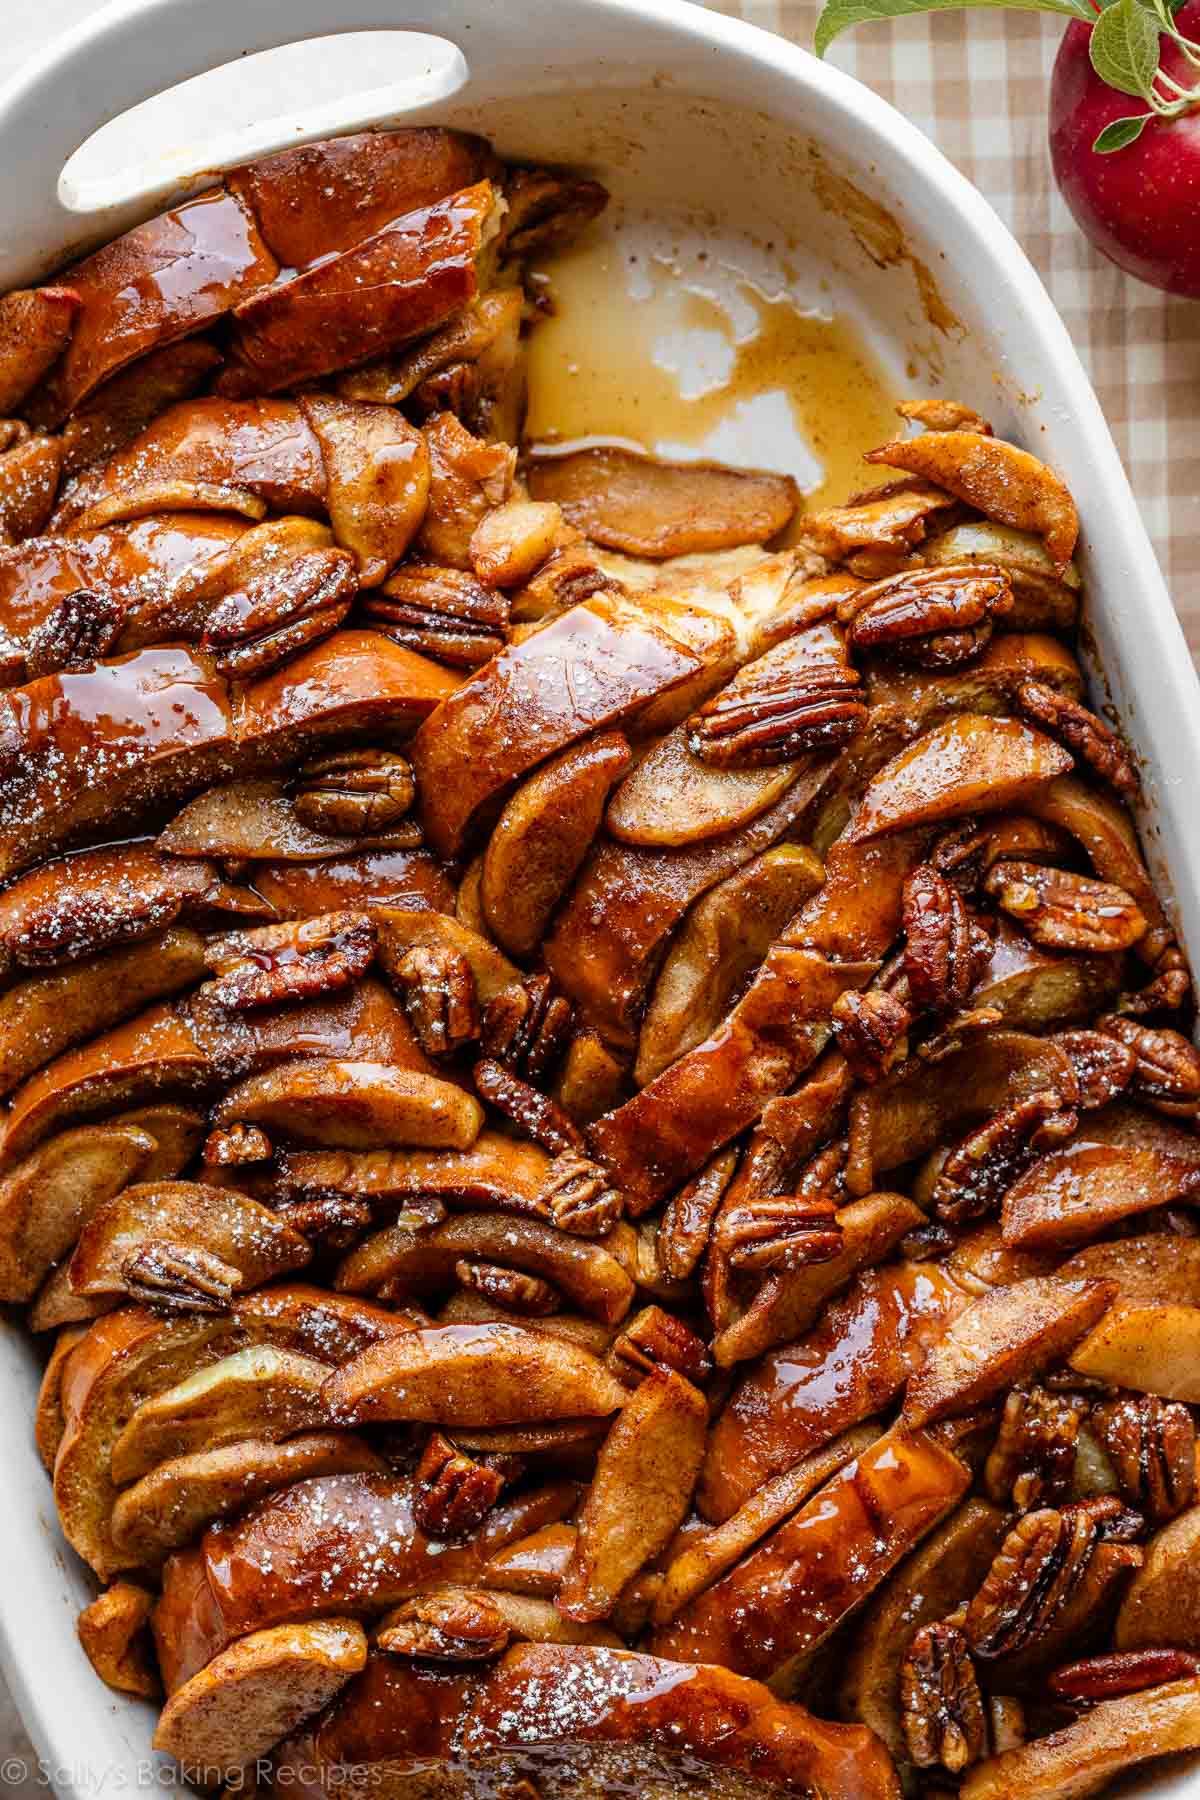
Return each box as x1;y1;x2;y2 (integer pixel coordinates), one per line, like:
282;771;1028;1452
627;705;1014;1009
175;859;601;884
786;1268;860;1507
70;1181;311;1310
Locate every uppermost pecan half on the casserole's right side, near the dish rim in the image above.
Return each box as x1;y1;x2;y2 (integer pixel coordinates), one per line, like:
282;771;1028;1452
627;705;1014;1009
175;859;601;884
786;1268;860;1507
838;562;1013;670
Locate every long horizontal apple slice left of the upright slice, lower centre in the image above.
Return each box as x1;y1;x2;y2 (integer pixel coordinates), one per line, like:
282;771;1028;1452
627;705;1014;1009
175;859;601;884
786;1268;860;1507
326;1325;626;1427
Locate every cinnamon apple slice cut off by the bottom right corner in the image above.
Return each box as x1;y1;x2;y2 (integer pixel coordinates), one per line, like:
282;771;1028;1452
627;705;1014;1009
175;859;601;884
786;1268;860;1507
959;1681;1200;1800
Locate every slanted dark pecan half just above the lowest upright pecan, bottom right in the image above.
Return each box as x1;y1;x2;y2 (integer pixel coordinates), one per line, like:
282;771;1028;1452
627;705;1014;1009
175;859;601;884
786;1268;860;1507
963;1499;1142;1660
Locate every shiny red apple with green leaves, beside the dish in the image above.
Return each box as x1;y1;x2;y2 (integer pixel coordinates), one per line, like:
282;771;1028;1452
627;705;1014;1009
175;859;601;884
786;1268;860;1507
1051;0;1200;299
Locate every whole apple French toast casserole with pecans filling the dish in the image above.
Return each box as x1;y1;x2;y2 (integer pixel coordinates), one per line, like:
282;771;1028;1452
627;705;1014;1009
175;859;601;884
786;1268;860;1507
0;130;1200;1800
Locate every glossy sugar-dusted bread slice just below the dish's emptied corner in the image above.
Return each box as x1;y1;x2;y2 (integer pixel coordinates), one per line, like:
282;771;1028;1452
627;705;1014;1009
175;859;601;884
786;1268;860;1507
412;592;734;857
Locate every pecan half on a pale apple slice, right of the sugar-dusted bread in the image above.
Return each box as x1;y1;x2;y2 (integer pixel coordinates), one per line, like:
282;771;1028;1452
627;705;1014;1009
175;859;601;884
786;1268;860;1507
687;659;867;769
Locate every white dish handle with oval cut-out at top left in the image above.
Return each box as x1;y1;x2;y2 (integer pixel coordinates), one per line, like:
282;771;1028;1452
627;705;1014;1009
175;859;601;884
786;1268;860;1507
0;0;528;288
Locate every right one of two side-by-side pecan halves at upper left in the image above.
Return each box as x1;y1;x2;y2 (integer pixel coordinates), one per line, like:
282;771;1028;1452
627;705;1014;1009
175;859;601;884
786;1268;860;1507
360;563;509;668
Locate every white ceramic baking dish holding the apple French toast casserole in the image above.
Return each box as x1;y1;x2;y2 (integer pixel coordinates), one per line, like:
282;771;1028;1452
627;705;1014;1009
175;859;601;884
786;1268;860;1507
0;0;1200;1796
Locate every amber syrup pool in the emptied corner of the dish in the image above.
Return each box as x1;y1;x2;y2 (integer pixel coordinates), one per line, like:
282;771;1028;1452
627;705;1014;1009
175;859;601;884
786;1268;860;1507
525;234;898;509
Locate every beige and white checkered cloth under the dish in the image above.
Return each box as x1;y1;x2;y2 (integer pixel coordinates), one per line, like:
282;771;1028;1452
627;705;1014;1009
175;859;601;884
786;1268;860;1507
714;0;1200;661
